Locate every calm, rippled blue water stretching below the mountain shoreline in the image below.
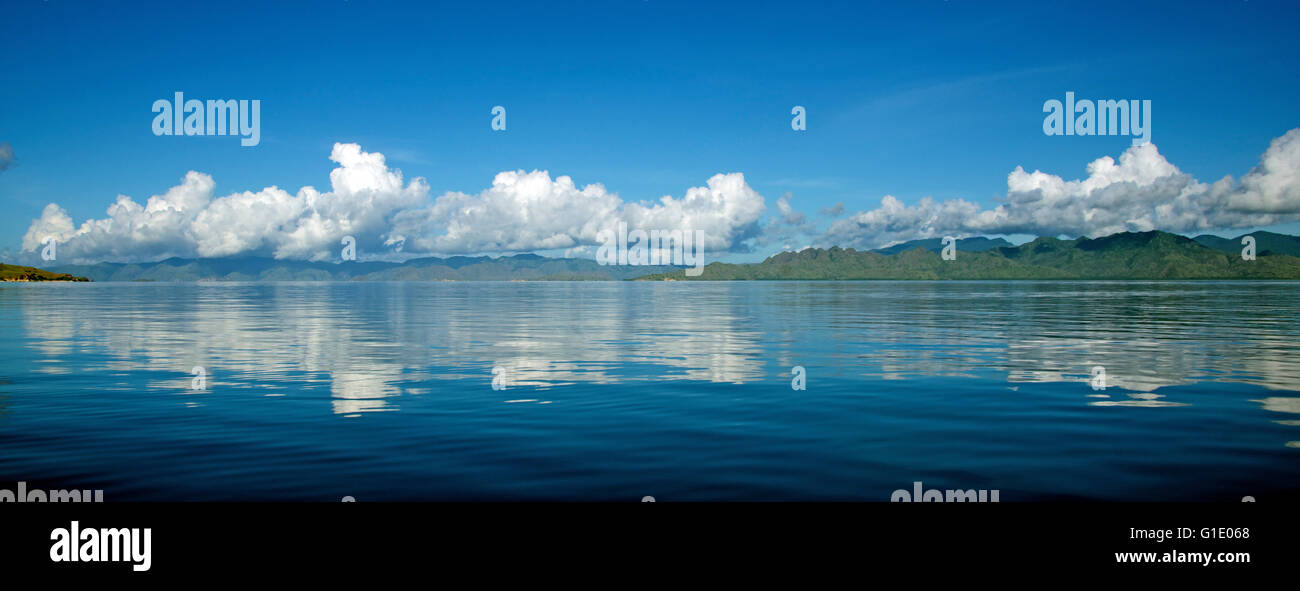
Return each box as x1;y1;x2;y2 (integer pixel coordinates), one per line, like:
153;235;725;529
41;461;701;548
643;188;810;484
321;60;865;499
0;282;1300;503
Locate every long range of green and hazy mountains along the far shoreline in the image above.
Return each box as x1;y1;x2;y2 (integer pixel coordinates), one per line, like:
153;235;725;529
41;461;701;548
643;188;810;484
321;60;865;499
10;231;1300;282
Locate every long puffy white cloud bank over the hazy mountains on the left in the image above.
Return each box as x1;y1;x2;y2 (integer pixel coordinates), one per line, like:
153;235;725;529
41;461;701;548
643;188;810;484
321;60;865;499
22;143;764;261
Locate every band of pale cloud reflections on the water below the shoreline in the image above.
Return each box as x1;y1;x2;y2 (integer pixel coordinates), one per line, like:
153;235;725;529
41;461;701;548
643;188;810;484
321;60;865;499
7;282;1300;416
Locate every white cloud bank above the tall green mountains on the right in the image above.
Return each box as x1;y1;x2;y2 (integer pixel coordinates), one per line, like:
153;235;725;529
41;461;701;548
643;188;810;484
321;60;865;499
816;129;1300;248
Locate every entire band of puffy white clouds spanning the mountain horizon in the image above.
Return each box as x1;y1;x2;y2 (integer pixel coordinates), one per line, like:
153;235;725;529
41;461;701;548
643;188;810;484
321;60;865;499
22;129;1300;262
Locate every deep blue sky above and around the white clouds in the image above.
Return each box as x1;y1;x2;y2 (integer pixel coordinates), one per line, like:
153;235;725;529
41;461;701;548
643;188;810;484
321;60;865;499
0;0;1300;260
